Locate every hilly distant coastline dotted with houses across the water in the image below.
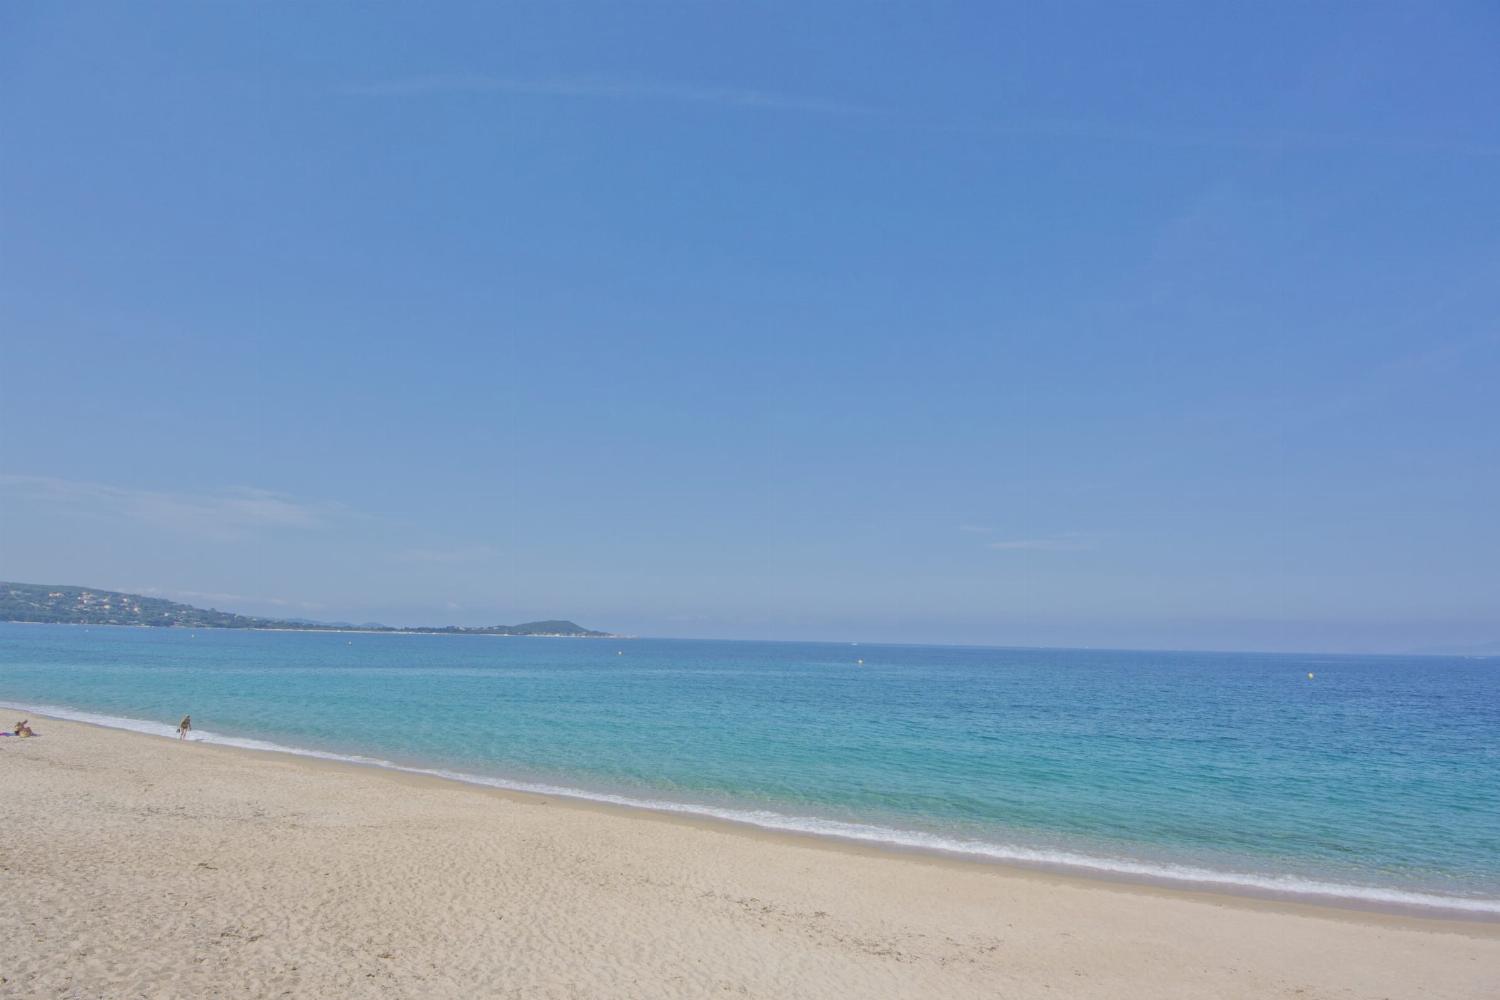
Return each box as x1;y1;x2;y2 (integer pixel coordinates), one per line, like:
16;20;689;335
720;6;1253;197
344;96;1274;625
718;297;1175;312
0;582;617;639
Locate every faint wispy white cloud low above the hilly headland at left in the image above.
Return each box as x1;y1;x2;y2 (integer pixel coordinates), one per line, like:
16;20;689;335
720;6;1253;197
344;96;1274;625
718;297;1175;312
0;475;351;538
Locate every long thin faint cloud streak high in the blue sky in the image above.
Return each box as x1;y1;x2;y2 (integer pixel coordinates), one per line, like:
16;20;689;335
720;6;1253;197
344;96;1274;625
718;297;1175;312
342;73;879;115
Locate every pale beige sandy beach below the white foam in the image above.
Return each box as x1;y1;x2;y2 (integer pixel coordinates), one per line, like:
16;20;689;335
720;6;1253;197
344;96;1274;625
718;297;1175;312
0;710;1500;1000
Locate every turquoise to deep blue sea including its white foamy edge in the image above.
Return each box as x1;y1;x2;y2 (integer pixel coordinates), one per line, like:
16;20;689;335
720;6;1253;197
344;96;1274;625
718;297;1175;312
0;625;1500;913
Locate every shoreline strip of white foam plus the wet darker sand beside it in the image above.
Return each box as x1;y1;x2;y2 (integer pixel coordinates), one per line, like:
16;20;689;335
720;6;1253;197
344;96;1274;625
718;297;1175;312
0;702;1500;925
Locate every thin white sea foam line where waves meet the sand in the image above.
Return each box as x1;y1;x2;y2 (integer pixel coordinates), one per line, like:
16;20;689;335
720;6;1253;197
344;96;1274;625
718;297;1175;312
11;705;1500;916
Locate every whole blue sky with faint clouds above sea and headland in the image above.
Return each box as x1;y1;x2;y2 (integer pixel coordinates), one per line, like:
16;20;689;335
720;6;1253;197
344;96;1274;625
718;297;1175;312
0;1;1500;652
